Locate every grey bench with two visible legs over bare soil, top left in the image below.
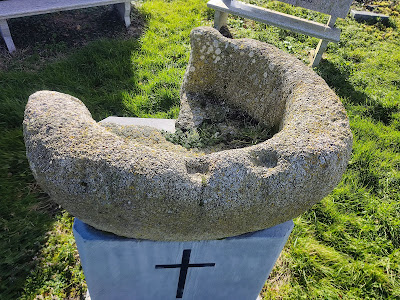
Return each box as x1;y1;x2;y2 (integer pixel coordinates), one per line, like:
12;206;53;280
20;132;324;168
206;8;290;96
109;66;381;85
0;0;131;53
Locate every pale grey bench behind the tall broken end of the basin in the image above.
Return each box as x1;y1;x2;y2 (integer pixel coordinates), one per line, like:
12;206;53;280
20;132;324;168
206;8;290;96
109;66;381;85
207;0;353;67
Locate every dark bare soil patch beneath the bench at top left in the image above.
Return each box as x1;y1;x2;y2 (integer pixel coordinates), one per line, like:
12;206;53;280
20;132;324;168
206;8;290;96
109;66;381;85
0;5;145;69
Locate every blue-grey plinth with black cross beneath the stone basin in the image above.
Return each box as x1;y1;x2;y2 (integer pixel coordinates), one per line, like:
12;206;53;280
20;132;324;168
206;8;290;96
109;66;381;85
73;219;293;300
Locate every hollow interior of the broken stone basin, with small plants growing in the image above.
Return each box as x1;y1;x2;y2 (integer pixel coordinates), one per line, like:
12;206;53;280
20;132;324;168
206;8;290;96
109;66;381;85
174;28;294;152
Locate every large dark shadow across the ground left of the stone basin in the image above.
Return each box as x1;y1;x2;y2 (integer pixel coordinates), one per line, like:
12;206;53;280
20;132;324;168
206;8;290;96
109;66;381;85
0;8;144;299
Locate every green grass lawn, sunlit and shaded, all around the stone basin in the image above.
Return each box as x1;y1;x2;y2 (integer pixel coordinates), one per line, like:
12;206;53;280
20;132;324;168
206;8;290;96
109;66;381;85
0;0;400;299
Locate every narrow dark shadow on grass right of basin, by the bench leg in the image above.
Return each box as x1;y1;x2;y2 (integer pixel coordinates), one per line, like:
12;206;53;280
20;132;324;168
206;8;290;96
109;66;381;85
316;60;398;125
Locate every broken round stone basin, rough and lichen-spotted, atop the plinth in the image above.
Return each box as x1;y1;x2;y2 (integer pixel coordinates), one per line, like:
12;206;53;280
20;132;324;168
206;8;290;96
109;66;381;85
24;27;352;241
